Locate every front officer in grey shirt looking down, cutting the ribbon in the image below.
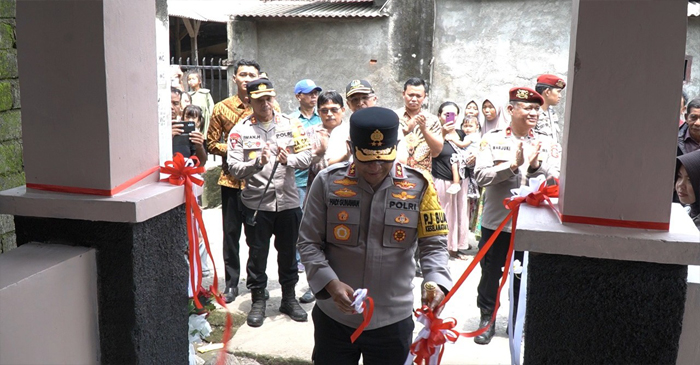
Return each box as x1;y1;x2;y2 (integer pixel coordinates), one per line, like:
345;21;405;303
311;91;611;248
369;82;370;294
298;107;452;365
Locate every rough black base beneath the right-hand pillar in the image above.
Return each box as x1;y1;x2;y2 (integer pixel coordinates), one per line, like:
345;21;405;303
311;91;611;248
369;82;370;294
524;253;687;364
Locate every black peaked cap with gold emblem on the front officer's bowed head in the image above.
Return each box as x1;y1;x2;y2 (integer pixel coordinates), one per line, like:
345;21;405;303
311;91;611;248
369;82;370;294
350;107;399;162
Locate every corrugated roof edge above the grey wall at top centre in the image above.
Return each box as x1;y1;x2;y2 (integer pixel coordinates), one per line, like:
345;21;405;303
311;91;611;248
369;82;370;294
231;1;389;18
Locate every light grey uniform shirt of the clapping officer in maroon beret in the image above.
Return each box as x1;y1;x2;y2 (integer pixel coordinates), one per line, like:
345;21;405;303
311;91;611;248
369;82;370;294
474;127;561;232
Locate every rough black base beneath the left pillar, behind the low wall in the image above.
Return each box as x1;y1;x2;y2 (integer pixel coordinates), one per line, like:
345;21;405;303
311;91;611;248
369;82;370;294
15;205;188;364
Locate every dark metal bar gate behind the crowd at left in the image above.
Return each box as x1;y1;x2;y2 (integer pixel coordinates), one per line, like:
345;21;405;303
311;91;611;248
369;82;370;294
170;57;229;103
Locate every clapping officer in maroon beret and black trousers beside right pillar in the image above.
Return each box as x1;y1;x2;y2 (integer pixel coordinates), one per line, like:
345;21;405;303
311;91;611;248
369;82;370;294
474;87;561;345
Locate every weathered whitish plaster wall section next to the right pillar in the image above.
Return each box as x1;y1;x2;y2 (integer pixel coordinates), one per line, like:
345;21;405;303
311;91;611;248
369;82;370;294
430;0;571;115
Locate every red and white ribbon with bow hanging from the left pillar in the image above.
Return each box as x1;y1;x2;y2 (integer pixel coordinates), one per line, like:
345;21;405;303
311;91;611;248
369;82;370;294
160;153;233;365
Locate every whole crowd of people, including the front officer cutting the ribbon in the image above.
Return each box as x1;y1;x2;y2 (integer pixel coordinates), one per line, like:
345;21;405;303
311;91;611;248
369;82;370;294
172;59;700;364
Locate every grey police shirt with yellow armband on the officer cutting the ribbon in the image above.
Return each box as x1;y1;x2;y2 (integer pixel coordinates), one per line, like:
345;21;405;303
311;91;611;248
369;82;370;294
297;162;452;330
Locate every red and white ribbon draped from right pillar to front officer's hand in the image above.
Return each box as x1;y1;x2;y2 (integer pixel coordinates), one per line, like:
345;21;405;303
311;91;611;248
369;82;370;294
411;179;560;365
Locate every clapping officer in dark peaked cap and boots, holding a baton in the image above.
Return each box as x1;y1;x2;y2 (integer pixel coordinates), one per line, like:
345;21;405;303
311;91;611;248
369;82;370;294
227;78;311;327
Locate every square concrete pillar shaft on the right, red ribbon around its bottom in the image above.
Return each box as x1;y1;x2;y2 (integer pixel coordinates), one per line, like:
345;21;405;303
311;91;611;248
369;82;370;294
560;0;688;230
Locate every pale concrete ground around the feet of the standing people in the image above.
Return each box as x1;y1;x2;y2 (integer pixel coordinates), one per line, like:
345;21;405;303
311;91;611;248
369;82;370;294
197;203;510;365
